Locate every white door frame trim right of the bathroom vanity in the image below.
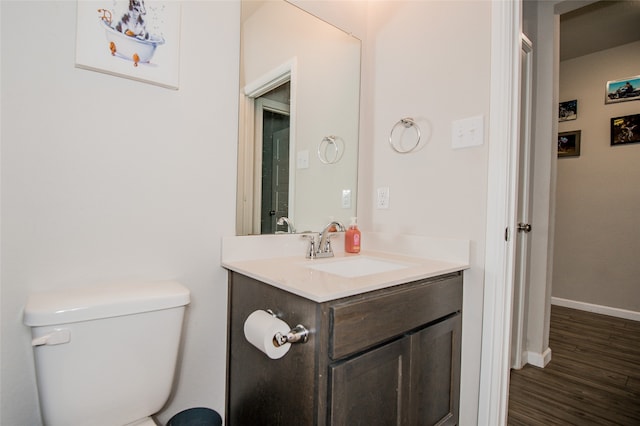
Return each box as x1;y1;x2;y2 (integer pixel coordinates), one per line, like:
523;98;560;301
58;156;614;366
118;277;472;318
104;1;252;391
478;0;522;426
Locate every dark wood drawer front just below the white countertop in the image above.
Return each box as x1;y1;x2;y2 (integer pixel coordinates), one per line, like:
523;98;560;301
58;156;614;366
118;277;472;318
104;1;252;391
329;274;462;360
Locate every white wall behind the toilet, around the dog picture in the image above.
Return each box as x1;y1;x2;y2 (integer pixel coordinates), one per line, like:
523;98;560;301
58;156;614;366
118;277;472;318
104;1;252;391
0;1;240;426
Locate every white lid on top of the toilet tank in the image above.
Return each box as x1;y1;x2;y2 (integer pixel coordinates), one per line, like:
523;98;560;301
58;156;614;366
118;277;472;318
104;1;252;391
23;281;190;326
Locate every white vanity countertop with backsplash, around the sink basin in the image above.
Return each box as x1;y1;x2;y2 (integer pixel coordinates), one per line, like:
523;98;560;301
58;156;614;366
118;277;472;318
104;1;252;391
222;232;470;302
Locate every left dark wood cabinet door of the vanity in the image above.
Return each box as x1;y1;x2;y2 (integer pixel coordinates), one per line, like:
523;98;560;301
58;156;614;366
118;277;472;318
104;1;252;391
329;337;411;426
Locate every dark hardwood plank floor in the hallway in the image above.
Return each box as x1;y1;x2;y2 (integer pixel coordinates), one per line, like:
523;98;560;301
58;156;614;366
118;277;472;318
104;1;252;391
508;306;640;426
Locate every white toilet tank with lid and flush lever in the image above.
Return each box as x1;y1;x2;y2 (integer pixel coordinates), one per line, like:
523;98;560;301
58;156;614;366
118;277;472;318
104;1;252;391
24;281;190;426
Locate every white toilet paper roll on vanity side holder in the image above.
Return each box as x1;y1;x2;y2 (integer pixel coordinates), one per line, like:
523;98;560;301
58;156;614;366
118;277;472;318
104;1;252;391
244;311;291;359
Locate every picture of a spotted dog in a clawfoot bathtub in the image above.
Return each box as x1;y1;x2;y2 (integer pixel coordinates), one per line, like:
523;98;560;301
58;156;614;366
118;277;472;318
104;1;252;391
76;0;181;89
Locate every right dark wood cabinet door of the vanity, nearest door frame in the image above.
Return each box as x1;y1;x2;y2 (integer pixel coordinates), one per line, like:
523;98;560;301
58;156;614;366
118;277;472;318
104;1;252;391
409;314;462;426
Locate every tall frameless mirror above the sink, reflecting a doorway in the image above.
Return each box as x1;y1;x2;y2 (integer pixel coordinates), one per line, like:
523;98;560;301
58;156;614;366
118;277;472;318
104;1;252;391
236;0;360;235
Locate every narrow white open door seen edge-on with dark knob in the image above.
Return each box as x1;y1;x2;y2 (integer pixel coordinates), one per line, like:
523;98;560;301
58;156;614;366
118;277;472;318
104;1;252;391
511;35;533;369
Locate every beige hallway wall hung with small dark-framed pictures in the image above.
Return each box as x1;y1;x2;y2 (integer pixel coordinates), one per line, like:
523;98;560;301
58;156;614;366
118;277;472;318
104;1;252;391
552;42;640;312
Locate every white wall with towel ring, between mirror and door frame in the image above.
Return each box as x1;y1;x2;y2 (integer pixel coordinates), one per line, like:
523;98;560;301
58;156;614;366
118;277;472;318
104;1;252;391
358;1;491;425
